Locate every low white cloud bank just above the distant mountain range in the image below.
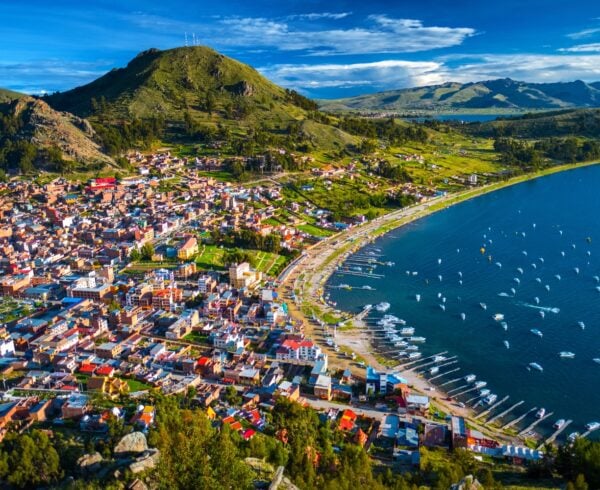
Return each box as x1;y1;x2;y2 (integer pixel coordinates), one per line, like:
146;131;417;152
259;54;600;93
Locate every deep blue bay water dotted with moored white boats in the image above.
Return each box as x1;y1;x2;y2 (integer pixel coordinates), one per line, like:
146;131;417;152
328;166;600;434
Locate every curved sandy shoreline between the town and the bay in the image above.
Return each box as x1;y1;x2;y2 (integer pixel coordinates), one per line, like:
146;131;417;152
278;161;600;443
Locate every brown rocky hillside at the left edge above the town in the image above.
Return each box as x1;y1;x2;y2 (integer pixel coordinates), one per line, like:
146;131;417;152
0;94;114;166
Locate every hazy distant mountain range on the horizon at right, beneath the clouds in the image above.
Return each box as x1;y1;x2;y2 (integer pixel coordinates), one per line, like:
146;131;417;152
320;78;600;112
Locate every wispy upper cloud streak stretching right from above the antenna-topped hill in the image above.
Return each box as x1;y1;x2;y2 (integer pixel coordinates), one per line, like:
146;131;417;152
130;14;476;55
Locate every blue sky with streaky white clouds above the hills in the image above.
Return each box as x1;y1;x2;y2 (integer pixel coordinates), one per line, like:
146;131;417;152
0;0;600;98
